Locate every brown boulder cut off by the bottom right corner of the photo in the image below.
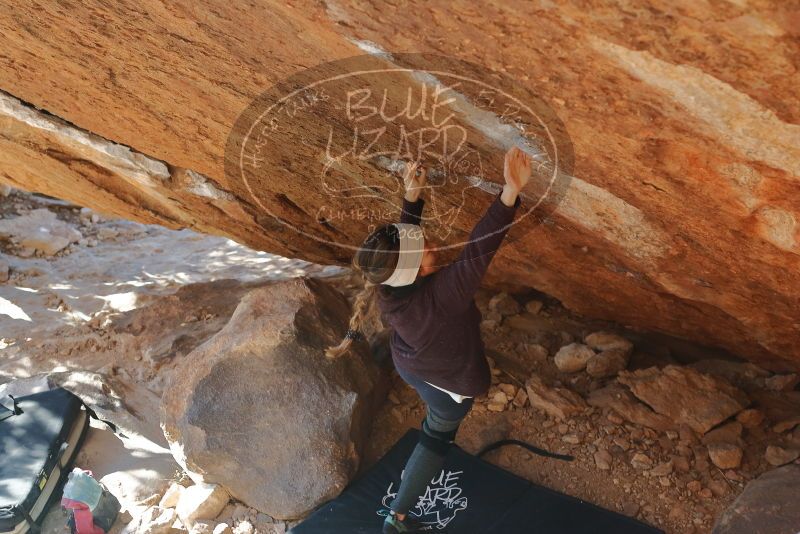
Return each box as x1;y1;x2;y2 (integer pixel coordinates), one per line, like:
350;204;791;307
713;465;800;534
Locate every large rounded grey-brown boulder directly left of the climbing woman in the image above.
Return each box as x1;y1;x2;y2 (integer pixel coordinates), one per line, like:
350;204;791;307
162;278;378;519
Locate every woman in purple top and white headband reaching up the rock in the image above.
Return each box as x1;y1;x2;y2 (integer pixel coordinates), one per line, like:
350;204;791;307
327;147;531;534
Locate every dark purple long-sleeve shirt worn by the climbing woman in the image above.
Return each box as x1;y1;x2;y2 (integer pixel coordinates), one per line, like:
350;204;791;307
378;195;520;397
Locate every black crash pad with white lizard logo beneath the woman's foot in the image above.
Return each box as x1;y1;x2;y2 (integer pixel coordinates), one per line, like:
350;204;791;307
290;430;662;534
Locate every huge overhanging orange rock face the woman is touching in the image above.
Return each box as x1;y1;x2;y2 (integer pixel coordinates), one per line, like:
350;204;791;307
0;0;800;369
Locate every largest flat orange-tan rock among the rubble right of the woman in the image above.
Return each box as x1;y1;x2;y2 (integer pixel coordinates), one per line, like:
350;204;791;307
619;365;750;434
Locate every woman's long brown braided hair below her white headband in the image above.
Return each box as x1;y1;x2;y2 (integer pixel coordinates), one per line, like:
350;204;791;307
325;224;400;358
